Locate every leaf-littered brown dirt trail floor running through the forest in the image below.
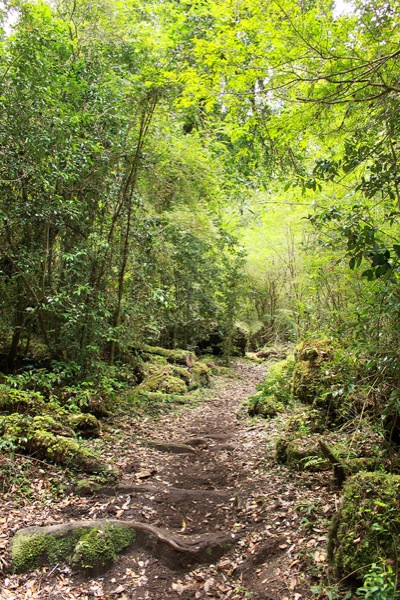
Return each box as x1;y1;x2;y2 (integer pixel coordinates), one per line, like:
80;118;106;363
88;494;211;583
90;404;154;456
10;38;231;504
0;361;337;600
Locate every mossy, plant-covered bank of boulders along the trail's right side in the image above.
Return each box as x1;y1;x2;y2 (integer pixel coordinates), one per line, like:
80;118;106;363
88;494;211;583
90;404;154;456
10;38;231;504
248;339;400;600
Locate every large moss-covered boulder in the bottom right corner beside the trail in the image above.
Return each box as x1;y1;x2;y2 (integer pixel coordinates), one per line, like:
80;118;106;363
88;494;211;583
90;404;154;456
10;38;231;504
328;472;400;580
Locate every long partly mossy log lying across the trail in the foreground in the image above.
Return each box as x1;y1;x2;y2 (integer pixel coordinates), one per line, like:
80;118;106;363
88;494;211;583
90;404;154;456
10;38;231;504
11;519;233;572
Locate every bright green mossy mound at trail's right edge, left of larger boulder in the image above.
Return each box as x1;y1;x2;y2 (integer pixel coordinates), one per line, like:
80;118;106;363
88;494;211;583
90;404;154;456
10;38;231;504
248;357;294;417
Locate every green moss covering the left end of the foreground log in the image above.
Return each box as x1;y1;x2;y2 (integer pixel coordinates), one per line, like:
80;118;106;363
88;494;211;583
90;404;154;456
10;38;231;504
11;524;136;573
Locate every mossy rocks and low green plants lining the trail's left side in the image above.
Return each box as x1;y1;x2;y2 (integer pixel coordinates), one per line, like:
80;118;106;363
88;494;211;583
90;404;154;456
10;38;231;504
0;347;215;498
